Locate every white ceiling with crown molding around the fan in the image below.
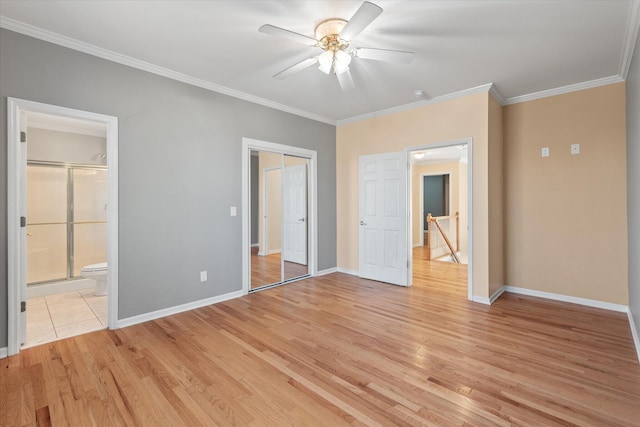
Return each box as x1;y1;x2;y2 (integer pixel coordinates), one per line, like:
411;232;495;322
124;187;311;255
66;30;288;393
0;0;640;123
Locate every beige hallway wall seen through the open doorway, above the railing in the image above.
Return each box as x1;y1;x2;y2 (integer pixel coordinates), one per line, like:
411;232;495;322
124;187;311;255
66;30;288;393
411;162;468;252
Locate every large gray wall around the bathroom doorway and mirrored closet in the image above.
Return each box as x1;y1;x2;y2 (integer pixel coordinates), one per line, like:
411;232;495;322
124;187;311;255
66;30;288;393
0;29;336;347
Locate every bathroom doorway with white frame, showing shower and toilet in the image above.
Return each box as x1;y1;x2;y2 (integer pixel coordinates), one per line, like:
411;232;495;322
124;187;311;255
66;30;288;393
8;98;117;355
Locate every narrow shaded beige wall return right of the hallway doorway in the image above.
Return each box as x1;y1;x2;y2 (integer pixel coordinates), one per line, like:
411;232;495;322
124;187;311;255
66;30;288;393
489;96;505;295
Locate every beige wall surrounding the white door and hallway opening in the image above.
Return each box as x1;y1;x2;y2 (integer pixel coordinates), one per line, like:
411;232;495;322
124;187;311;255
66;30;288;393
336;93;490;298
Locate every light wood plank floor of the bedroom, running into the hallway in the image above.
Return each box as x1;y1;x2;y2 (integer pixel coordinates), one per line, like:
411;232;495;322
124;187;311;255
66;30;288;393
0;254;640;427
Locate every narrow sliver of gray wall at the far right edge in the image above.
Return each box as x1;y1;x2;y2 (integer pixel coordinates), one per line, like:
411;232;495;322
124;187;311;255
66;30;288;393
627;38;640;357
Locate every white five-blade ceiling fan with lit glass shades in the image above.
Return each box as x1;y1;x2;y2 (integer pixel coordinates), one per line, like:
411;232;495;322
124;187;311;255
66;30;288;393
258;1;414;91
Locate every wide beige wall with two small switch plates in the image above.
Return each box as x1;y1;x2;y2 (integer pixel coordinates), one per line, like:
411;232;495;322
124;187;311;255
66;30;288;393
503;83;628;305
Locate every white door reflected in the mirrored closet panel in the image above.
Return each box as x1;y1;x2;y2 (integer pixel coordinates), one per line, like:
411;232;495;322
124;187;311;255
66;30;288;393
282;164;307;265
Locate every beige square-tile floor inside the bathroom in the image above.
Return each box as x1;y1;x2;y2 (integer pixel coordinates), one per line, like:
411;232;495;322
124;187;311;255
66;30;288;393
22;289;107;348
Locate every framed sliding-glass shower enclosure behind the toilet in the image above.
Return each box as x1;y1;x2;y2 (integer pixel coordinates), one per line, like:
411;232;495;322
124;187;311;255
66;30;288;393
27;161;107;286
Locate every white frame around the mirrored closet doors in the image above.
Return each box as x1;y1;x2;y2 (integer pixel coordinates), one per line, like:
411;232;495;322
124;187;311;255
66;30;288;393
242;137;318;295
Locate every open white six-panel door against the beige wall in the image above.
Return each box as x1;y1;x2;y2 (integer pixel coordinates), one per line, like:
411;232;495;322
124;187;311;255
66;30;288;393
359;152;409;286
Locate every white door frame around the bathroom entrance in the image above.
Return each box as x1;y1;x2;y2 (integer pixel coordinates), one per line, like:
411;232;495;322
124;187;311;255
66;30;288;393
7;97;118;356
